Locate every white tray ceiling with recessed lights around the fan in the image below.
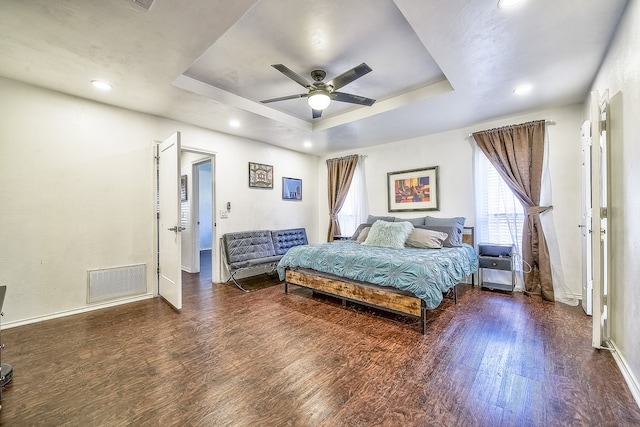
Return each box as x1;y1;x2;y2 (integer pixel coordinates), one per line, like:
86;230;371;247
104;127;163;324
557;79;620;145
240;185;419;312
0;0;627;155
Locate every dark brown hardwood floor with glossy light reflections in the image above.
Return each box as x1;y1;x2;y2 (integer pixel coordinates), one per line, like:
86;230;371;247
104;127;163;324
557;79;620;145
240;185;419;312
0;262;640;426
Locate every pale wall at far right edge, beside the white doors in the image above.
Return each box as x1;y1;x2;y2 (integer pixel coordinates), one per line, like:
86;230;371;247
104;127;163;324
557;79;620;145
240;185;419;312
585;0;640;403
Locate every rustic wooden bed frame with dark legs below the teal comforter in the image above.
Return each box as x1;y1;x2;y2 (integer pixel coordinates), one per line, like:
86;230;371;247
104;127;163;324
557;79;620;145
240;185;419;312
284;269;457;334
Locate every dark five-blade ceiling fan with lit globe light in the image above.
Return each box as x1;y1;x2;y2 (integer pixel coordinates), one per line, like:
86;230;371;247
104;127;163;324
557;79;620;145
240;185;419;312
260;62;376;119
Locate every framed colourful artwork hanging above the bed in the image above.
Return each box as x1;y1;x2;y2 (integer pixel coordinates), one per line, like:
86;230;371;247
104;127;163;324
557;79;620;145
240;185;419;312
387;166;440;212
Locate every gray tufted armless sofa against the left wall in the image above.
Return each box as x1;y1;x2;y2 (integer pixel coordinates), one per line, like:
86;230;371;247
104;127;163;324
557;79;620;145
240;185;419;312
220;228;307;292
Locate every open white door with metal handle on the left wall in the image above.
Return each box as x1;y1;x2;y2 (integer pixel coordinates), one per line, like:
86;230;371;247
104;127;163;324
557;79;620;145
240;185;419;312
158;132;183;310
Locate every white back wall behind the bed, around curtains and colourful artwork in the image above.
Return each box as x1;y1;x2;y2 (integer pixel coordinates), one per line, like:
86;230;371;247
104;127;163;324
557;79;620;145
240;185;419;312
318;105;582;296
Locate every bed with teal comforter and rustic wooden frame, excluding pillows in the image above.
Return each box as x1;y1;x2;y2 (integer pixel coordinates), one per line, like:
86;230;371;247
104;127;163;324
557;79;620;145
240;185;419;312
277;221;478;334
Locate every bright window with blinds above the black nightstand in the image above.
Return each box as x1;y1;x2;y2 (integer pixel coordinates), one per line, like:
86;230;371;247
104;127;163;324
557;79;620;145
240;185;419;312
476;153;525;264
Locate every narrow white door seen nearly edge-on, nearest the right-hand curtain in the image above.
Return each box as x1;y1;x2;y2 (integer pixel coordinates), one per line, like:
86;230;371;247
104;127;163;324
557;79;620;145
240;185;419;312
580;121;593;316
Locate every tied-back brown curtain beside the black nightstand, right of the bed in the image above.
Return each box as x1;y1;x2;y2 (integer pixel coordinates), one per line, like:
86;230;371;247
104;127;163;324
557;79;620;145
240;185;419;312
473;120;554;301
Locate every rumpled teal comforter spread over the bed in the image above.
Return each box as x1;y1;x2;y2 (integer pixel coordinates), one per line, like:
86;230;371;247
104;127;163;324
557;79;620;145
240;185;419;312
278;241;478;309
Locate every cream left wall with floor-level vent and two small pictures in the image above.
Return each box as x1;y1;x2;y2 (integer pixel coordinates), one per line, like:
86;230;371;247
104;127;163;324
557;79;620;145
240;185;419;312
0;79;318;326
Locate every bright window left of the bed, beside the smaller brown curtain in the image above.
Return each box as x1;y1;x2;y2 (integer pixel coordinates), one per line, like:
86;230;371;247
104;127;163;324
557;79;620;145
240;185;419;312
338;156;369;236
